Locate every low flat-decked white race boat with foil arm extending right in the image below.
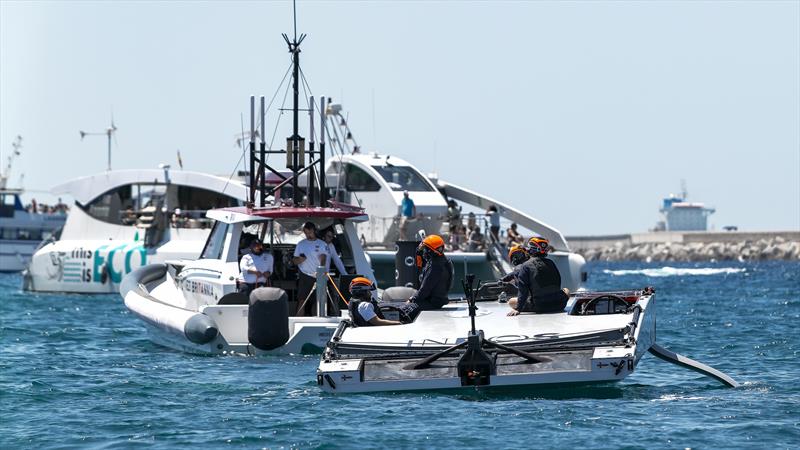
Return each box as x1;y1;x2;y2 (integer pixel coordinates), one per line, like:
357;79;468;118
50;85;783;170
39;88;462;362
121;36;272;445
317;277;737;393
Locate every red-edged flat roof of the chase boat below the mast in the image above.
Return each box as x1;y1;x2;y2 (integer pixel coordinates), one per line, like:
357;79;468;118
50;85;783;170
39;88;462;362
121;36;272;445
206;206;368;223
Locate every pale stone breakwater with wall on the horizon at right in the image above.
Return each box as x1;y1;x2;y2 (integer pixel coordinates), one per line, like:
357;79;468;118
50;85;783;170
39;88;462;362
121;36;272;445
566;231;800;262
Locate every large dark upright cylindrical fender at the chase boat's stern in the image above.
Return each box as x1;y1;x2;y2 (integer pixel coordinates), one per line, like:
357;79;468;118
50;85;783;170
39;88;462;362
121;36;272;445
247;287;289;350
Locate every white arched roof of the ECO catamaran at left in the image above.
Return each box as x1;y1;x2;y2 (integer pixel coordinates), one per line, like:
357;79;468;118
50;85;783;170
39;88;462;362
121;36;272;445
51;169;247;204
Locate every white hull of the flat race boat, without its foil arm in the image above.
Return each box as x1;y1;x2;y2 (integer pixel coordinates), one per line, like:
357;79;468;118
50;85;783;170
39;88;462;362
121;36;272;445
317;295;655;393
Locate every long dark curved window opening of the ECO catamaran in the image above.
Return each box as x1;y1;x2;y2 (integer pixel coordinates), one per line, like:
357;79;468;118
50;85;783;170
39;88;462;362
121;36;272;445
82;183;240;228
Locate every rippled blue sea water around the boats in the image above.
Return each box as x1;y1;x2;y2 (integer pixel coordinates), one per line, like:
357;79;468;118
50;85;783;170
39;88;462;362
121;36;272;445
0;262;800;449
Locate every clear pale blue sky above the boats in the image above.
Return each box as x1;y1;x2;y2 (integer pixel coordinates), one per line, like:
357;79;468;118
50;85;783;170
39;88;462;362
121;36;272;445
0;0;800;236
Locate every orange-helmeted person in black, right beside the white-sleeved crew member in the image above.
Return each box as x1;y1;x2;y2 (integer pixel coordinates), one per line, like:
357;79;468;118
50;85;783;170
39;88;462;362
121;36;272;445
408;234;453;311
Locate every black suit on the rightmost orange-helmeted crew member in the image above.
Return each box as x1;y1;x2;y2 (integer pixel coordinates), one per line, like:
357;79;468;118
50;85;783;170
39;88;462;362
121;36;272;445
516;256;569;313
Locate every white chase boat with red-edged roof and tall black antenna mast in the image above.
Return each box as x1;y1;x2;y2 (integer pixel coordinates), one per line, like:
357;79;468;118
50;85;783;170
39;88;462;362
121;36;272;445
120;29;374;355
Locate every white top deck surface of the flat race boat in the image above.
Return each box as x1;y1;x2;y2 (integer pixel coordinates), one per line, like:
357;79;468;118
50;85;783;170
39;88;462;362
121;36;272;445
341;302;633;347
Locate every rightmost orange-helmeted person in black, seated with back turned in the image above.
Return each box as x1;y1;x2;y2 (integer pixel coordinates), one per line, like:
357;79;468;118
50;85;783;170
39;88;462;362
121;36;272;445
508;237;569;316
